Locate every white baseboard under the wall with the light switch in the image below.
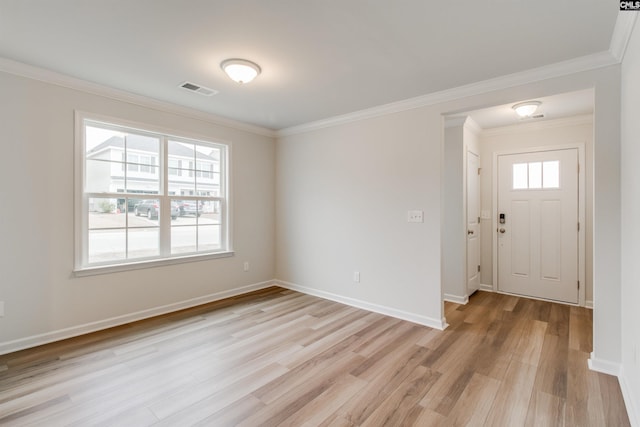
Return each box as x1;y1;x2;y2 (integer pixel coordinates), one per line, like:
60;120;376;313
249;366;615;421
274;279;448;330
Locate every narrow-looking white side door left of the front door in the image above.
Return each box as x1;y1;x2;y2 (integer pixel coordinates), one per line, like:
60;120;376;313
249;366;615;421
466;151;480;295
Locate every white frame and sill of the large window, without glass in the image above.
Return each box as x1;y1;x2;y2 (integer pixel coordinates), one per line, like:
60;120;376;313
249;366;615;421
73;111;234;276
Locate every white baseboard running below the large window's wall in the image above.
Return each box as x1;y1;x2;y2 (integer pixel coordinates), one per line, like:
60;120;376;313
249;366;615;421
0;280;275;355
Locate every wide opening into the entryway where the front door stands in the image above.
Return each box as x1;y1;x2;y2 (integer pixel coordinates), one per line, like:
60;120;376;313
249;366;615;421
441;89;594;308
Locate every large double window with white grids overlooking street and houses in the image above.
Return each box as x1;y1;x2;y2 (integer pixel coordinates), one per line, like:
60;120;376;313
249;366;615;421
76;113;230;272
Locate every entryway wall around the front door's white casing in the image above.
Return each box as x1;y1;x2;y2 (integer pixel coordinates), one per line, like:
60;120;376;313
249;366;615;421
480;115;593;304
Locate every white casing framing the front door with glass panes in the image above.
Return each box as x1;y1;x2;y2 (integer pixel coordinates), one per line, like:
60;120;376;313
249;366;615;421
491;142;587;307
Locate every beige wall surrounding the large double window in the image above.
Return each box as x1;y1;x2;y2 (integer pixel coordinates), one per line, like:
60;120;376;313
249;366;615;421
0;73;275;352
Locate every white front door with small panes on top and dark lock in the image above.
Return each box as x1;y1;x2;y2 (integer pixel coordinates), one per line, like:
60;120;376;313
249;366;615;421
496;149;579;303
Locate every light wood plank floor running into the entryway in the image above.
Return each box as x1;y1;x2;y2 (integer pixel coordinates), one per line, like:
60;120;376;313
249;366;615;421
0;288;629;427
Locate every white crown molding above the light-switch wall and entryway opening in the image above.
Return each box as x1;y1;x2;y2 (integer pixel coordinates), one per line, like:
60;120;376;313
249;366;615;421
276;51;620;137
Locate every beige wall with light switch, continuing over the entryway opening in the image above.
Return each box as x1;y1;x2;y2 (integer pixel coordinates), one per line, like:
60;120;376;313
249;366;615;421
276;66;620;354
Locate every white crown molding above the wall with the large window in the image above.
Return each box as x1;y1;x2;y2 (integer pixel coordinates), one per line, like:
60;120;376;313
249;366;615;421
0;57;276;138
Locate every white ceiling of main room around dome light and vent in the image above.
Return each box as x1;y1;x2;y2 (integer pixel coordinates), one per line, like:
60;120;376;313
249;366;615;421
0;0;618;129
